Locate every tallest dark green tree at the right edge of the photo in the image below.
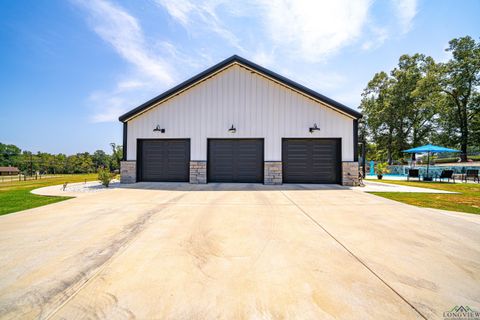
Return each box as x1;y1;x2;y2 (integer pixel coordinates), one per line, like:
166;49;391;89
438;36;480;161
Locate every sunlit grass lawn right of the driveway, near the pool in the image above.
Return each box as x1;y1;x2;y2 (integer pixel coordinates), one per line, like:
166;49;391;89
372;180;480;214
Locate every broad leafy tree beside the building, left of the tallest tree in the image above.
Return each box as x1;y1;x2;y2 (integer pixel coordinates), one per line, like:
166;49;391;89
360;54;437;164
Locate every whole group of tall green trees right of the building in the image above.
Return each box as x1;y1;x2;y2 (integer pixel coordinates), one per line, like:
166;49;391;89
359;36;480;164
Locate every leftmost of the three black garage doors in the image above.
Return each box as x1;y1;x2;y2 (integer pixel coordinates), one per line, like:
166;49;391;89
137;139;190;182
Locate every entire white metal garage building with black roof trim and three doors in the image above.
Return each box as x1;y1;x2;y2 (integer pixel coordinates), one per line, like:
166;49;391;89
119;56;361;185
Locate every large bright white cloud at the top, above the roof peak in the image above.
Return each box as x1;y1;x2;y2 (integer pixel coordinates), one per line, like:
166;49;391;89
156;0;372;62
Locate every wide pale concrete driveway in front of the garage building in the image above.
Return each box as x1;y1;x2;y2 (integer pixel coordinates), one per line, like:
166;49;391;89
0;183;480;319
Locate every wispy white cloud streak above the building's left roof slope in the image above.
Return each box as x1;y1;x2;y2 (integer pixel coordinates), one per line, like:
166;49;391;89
75;0;181;122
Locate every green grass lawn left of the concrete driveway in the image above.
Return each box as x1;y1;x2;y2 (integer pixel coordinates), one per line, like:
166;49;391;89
0;174;97;215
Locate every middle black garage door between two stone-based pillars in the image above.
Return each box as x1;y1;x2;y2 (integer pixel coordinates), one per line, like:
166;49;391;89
207;139;263;183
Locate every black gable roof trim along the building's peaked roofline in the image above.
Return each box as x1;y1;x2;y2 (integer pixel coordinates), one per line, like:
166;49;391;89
118;55;362;122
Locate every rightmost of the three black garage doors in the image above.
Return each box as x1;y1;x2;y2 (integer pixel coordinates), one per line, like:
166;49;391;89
282;139;341;183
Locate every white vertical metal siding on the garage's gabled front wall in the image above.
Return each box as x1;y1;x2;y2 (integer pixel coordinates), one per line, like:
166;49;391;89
127;65;353;161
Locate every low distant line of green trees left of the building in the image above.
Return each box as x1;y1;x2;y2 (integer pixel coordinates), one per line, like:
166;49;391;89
0;143;123;175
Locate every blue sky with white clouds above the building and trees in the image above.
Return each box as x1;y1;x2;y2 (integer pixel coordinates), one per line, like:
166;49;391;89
0;0;480;154
